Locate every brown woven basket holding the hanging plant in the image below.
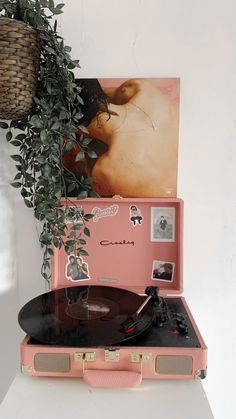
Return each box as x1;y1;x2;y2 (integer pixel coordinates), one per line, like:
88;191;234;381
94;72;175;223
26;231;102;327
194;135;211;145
0;17;40;119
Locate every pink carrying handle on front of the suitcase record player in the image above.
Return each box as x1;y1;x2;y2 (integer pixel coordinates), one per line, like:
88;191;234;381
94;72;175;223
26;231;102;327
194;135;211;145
83;369;142;388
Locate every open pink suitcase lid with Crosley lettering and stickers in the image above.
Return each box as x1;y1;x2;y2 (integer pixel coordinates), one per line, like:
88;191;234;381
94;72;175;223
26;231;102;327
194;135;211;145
51;198;183;295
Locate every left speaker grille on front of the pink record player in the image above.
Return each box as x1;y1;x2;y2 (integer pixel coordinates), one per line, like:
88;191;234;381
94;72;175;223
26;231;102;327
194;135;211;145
34;353;70;372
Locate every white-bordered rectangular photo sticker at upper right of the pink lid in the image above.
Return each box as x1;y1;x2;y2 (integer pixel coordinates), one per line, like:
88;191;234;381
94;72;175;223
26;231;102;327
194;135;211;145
151;207;175;242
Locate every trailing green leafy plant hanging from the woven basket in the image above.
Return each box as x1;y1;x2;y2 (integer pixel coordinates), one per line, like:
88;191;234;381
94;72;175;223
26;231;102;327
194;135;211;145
0;0;97;280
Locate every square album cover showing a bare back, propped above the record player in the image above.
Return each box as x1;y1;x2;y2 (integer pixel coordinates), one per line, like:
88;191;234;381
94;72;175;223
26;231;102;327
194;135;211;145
65;78;180;198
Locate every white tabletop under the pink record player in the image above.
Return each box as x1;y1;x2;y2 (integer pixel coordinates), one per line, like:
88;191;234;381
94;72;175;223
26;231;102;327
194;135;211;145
0;373;213;419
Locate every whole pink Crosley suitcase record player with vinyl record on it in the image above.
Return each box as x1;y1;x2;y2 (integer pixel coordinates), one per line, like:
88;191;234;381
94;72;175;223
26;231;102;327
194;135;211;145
19;198;207;387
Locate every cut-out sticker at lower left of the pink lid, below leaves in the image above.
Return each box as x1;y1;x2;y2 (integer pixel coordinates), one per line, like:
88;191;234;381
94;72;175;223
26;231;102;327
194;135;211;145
66;255;90;282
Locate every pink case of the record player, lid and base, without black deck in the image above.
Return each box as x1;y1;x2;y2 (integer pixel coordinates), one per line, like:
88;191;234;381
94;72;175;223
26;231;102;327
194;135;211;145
21;198;207;387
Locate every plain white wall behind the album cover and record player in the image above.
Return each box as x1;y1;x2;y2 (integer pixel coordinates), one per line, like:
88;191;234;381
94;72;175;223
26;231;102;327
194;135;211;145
0;0;236;419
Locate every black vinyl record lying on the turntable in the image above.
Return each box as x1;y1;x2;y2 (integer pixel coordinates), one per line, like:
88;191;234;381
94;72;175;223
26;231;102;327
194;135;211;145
19;286;154;347
